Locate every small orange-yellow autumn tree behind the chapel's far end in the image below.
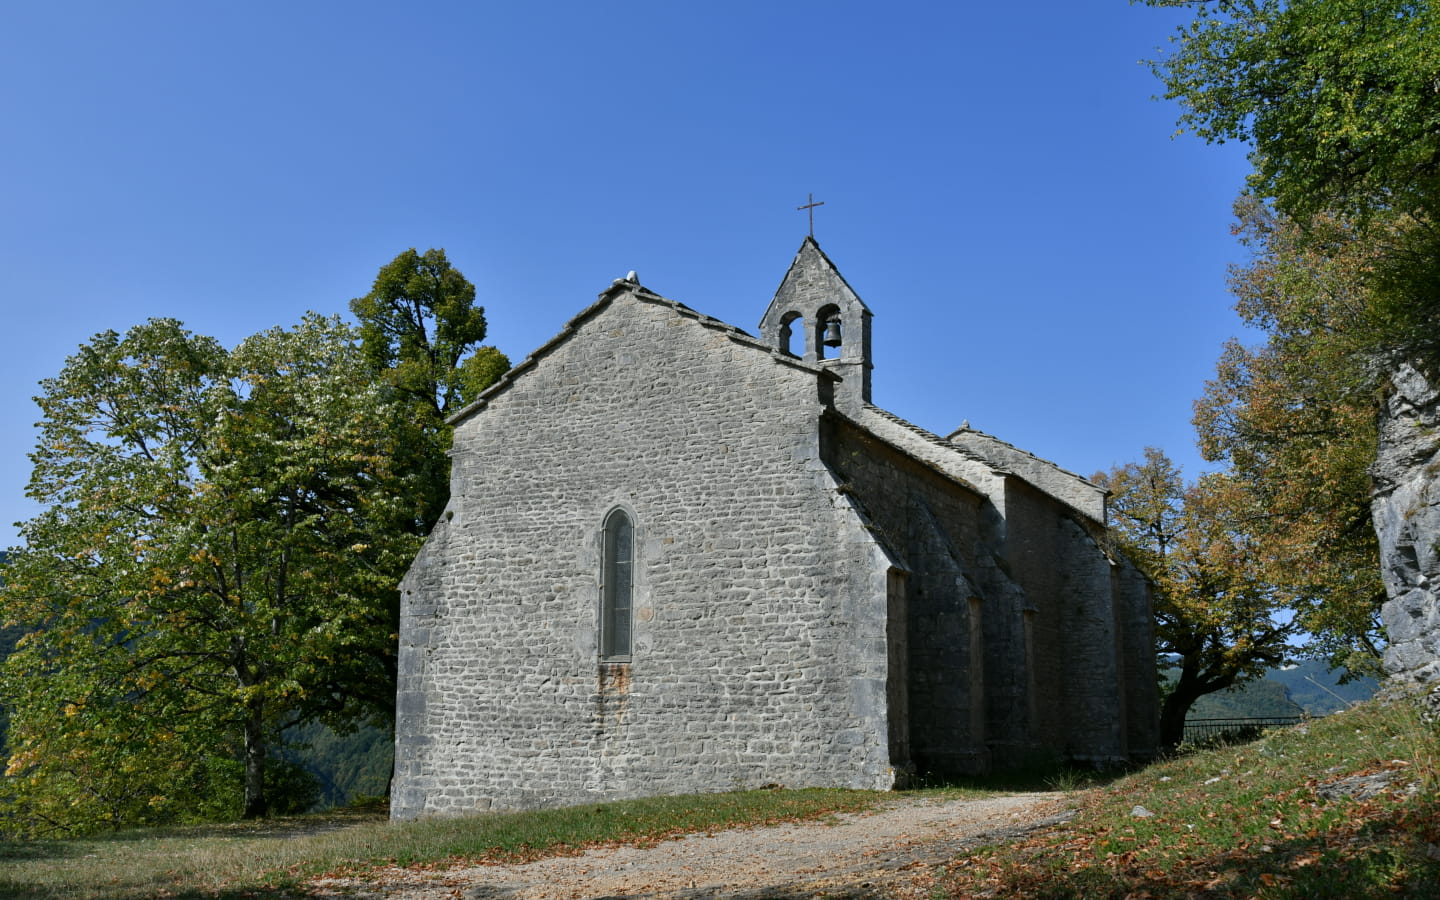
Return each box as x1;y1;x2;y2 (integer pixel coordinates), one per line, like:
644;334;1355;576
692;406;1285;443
1093;448;1295;746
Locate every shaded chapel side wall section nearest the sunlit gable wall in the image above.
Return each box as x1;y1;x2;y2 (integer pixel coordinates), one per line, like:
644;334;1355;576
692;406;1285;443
822;419;1012;775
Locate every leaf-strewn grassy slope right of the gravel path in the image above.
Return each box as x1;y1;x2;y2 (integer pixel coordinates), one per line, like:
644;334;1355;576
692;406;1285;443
935;688;1440;900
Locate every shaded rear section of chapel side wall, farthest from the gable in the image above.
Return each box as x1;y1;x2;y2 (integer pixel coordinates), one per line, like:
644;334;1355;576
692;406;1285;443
996;480;1128;763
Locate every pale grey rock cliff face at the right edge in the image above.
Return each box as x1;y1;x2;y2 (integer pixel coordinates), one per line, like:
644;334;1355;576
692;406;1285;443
1371;364;1440;683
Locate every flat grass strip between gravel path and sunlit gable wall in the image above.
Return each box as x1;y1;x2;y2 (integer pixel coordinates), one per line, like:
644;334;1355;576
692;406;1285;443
0;789;887;900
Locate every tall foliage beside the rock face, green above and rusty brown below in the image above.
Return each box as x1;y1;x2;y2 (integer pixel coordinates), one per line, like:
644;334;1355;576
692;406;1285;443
1146;0;1440;668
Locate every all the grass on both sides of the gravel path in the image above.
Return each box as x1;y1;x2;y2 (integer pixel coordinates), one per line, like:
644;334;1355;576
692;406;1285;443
0;691;1440;900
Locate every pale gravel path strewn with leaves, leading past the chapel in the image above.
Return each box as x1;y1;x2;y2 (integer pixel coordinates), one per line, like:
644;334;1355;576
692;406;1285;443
310;793;1070;900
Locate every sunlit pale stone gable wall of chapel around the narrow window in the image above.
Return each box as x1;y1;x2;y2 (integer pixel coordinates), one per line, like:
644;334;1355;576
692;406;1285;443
396;292;893;818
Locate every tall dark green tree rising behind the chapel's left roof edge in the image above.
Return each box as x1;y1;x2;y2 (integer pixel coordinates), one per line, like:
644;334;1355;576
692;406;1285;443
350;248;510;534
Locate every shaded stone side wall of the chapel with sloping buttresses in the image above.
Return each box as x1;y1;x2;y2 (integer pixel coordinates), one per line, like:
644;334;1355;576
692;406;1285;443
822;418;1158;775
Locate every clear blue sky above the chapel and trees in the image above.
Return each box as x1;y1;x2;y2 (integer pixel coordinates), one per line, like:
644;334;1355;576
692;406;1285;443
0;0;1247;544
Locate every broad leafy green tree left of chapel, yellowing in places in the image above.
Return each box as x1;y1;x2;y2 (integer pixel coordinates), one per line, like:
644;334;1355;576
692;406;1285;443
3;315;418;827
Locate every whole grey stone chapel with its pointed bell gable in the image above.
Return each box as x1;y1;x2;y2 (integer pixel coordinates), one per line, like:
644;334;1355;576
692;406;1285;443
392;238;1158;819
